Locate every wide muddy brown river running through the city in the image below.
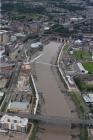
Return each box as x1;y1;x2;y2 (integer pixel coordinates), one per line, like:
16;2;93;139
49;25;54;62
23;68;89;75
32;42;78;140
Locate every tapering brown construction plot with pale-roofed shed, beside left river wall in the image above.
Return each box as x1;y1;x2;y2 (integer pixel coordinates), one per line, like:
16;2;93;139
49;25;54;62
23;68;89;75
7;64;35;113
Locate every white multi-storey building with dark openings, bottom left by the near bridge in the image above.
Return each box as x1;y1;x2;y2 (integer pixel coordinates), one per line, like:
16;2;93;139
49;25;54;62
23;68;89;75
0;114;28;133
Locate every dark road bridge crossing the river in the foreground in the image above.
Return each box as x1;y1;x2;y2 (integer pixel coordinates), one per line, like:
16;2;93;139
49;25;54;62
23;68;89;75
0;112;93;128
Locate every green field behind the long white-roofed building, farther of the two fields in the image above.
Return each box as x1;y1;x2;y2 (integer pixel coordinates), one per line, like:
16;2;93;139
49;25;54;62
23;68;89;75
73;50;91;60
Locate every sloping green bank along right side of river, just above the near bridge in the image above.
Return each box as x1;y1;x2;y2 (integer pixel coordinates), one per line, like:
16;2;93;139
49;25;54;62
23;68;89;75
70;93;89;119
